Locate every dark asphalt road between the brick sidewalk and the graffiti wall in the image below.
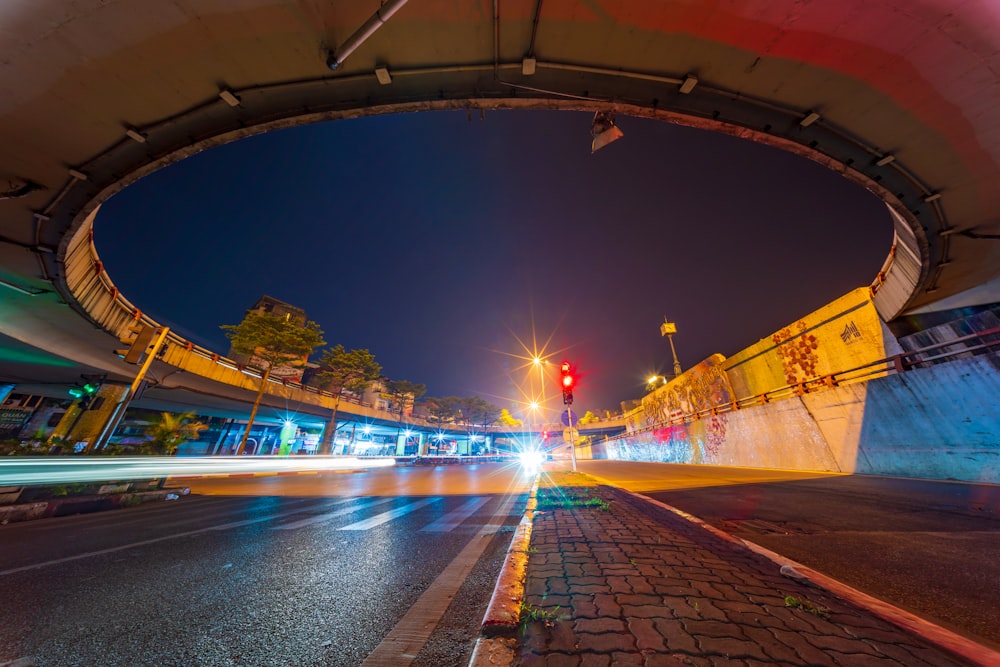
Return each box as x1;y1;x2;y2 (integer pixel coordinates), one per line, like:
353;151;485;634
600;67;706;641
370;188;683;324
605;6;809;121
579;461;1000;648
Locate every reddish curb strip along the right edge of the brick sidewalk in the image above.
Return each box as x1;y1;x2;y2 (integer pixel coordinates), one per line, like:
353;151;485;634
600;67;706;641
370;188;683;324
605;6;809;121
624;485;1000;667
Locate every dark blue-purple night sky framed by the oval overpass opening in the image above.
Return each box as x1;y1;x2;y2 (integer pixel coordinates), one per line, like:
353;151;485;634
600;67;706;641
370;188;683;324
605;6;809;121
94;111;892;414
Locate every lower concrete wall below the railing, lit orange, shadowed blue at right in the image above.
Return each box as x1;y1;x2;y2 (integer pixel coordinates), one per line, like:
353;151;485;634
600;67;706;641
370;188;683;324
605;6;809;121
607;353;1000;483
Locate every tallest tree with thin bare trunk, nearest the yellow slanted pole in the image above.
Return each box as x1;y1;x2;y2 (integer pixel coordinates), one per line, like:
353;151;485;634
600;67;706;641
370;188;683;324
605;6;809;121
222;311;326;455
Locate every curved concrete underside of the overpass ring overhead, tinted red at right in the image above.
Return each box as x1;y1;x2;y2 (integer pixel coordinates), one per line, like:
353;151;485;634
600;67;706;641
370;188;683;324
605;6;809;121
0;0;1000;361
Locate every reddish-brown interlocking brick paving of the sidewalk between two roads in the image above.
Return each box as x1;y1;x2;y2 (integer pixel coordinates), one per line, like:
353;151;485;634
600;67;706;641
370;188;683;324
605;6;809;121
519;487;968;667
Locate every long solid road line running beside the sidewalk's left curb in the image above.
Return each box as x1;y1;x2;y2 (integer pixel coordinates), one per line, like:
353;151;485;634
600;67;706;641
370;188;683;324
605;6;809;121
361;495;514;667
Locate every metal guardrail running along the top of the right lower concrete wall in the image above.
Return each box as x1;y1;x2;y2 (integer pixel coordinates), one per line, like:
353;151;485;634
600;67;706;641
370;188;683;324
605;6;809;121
608;327;1000;441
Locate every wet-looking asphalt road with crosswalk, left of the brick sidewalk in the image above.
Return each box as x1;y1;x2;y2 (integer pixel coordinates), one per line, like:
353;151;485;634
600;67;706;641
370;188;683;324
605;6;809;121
0;464;530;667
